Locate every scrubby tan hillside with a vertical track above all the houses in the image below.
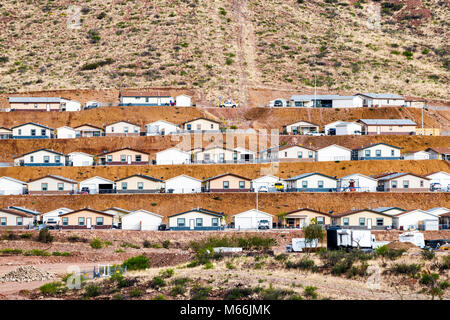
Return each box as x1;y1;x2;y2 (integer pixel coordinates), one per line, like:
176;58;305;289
0;0;449;103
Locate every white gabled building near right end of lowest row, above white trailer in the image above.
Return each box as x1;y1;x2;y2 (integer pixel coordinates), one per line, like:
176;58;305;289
392;209;439;230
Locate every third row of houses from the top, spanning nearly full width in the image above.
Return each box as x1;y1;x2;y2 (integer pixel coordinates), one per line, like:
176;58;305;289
13;142;450;167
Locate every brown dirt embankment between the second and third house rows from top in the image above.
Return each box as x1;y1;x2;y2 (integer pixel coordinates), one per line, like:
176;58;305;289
0;134;450;162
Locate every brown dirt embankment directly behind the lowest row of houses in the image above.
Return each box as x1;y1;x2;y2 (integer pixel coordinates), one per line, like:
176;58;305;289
0;192;450;220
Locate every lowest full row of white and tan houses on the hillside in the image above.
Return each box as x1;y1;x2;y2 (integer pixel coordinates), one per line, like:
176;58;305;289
0;206;450;231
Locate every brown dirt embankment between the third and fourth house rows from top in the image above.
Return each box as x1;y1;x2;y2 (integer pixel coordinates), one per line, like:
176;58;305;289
0;160;450;181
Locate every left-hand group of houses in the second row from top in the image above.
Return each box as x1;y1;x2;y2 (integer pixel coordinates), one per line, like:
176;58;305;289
0;118;220;139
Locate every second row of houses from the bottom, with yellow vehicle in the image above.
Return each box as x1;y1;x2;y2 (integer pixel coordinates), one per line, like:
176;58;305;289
0;171;450;195
